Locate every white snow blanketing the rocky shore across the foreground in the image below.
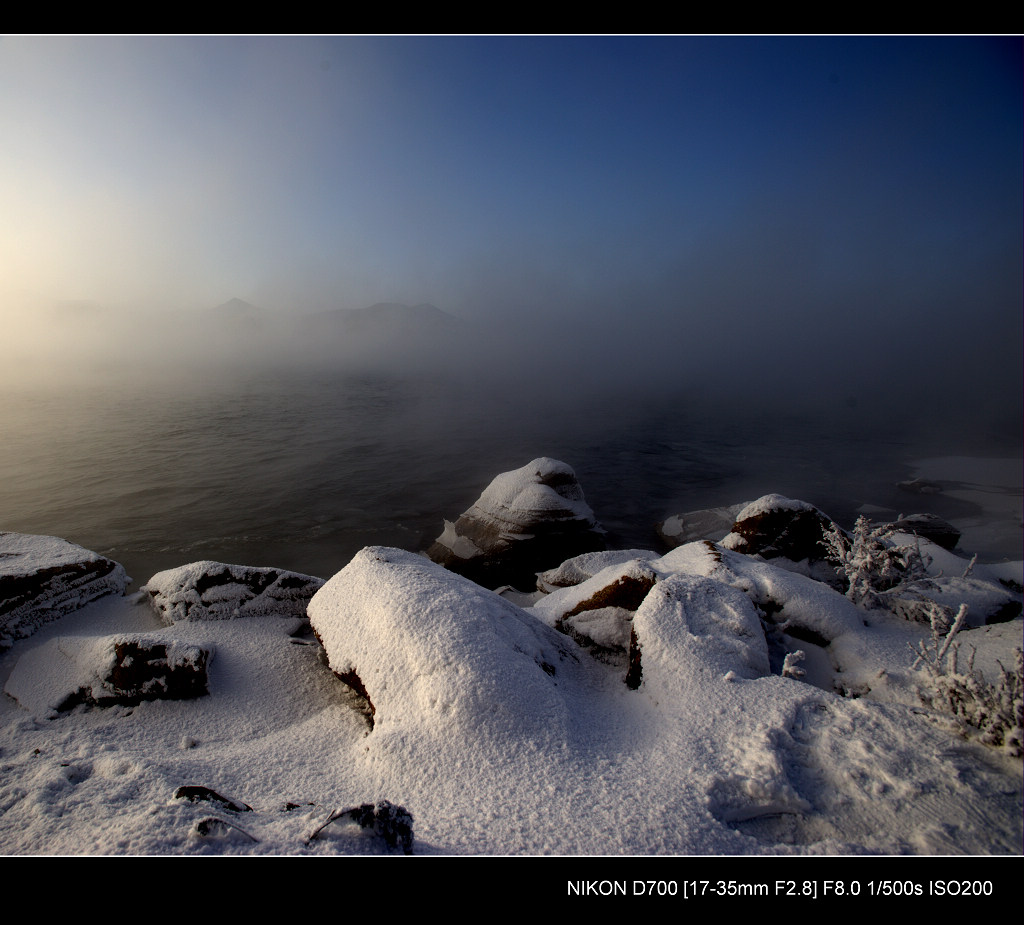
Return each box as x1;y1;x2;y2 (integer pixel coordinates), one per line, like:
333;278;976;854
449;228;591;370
0;458;1024;855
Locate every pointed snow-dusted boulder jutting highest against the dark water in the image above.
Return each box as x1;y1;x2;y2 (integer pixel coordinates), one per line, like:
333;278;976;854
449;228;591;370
427;457;605;590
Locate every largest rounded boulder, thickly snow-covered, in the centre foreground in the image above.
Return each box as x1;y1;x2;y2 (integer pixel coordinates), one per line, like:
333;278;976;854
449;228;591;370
309;546;578;746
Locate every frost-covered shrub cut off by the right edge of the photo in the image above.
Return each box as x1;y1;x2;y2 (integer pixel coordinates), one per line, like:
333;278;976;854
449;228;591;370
913;604;1024;758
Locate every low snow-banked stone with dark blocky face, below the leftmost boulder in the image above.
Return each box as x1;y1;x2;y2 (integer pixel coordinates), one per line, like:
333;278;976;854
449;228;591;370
4;633;213;716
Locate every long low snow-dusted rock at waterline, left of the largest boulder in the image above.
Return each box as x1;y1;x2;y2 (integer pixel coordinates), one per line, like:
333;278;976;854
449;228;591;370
141;560;324;625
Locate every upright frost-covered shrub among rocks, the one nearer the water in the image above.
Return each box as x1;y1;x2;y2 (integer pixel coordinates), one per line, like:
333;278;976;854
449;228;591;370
821;516;931;609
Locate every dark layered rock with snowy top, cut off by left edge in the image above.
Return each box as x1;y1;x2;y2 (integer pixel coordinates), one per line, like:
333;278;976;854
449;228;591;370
0;533;131;648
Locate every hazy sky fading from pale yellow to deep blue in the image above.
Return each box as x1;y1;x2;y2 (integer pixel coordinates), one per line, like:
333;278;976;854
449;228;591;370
0;36;1024;428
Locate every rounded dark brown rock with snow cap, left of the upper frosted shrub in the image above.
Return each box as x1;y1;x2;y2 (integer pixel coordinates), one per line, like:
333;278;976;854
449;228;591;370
722;495;835;562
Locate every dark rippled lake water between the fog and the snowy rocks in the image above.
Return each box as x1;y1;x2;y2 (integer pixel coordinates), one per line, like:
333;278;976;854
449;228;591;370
0;338;1009;583
